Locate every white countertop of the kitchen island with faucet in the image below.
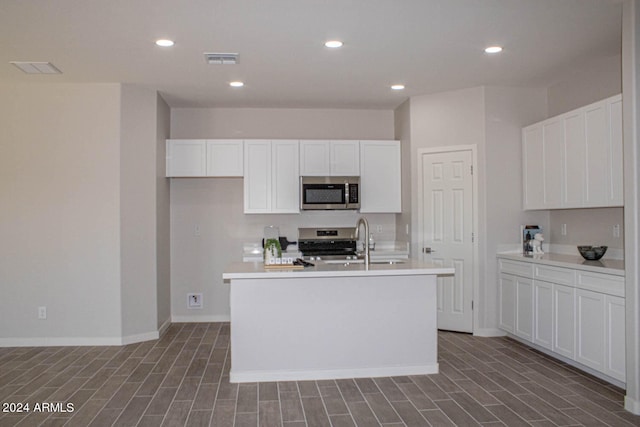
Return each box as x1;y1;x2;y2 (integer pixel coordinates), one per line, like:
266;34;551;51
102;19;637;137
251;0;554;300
222;259;455;279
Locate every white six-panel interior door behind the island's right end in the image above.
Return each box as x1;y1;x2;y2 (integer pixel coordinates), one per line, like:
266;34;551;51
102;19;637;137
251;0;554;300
420;150;474;332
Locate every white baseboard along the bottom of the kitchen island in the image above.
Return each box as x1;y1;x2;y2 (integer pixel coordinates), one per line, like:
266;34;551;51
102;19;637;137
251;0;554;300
229;363;439;383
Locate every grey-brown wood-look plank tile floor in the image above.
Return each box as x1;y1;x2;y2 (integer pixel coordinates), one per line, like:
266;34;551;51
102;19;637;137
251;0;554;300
0;323;640;427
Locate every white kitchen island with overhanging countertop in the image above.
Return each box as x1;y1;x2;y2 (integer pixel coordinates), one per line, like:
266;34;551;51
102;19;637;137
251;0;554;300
223;259;454;382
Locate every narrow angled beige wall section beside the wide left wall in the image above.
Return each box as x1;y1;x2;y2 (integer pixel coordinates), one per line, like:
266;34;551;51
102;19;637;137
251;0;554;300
120;85;158;339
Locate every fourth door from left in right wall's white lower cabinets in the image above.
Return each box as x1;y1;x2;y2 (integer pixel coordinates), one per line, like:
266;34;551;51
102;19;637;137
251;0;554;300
551;284;576;359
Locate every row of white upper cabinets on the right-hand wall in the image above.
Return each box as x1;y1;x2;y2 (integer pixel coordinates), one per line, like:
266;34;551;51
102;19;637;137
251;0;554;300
522;95;623;209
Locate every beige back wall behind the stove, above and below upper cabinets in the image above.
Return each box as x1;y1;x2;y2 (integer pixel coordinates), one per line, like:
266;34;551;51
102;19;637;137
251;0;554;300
171;108;395;321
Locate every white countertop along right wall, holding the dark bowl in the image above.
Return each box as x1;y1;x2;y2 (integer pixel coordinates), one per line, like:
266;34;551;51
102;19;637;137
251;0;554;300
497;252;624;276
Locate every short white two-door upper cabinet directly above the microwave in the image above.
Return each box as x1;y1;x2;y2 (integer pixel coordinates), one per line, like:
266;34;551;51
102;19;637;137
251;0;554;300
300;140;360;176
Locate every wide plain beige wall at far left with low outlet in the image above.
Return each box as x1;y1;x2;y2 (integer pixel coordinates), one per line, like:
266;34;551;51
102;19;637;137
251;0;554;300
0;84;122;345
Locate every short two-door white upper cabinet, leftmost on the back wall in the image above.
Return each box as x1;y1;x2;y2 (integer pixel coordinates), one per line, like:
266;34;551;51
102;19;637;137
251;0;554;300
166;139;243;177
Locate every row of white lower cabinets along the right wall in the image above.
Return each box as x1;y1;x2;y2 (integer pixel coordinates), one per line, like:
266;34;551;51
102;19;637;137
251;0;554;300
498;259;626;383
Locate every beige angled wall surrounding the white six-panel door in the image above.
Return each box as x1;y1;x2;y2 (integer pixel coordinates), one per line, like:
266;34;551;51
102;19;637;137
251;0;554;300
396;87;548;334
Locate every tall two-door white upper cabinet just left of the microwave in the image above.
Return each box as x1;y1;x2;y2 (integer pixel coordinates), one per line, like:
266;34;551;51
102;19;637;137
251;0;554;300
244;140;300;214
